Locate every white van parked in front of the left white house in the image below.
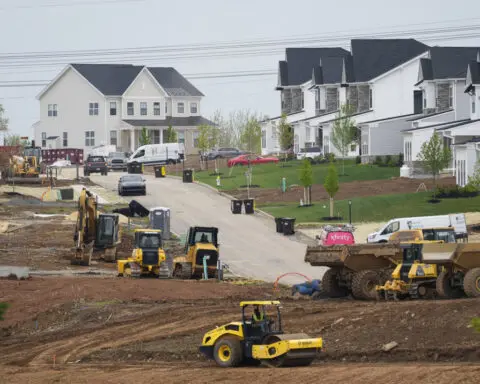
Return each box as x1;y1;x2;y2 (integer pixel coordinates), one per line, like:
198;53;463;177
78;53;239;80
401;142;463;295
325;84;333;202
128;143;185;165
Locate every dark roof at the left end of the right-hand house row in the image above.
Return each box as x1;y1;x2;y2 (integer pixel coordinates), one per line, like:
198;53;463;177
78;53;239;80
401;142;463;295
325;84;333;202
278;48;349;87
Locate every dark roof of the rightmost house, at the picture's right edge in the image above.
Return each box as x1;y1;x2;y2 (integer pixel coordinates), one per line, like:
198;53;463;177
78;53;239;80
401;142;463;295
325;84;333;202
418;47;480;82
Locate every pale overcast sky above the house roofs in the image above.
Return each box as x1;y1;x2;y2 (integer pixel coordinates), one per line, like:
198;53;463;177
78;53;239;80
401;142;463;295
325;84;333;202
0;0;480;136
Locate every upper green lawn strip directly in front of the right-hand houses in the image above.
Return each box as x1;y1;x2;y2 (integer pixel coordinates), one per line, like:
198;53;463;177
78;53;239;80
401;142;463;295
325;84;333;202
195;160;400;191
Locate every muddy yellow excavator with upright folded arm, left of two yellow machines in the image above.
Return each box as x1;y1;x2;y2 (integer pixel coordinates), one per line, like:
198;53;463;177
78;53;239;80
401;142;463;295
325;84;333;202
71;188;121;265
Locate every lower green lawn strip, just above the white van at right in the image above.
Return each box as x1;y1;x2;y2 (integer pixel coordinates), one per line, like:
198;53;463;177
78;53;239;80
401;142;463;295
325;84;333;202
258;192;480;223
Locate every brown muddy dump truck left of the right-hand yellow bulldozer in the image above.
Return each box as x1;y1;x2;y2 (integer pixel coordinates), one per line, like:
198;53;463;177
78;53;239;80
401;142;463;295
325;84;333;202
305;243;402;300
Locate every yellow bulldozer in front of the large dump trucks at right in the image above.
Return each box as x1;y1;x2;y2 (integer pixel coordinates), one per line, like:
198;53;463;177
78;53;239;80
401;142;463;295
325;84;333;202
375;240;443;300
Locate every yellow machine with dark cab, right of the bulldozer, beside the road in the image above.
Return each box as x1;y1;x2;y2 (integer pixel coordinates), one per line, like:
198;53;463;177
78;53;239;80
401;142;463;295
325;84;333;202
173;227;219;279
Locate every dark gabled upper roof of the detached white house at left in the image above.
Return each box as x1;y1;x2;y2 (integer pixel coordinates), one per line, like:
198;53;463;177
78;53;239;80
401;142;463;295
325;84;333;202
72;64;204;96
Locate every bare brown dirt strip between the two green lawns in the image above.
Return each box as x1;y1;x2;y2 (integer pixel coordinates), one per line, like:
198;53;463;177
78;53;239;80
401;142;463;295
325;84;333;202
229;177;455;203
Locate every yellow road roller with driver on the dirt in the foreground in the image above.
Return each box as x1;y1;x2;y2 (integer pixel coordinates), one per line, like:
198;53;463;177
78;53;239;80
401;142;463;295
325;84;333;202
200;301;323;367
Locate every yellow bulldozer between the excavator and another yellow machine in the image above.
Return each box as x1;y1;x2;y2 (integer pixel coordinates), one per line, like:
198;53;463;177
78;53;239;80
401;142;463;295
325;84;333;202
117;229;170;278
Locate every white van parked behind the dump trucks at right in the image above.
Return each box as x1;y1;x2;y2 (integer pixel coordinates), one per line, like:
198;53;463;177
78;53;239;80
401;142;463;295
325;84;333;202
367;213;467;243
